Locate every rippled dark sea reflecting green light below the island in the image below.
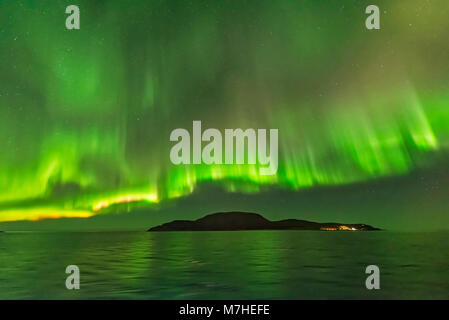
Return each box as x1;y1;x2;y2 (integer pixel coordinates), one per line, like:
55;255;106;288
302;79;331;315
0;231;449;299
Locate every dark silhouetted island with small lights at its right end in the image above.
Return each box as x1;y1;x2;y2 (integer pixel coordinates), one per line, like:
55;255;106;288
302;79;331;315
148;212;380;232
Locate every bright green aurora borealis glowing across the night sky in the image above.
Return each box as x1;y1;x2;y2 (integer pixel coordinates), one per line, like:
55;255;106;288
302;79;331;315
0;0;449;227
